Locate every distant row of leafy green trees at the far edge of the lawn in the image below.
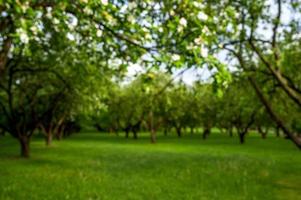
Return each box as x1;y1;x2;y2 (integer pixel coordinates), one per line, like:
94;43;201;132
90;73;301;143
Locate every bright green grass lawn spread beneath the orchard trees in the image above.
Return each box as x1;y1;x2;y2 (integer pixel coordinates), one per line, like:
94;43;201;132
0;133;301;200
